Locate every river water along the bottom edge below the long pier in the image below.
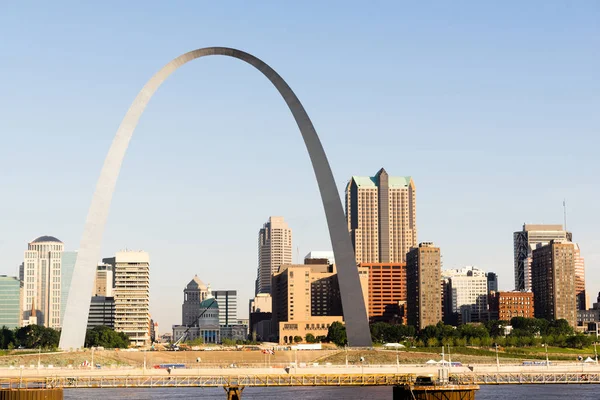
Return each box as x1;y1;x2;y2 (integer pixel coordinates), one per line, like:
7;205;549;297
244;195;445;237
65;384;600;400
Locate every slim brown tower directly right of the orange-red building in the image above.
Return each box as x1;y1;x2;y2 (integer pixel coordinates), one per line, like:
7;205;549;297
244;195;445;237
406;243;442;329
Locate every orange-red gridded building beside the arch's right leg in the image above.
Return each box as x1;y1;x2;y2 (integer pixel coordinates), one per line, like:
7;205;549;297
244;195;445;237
359;263;406;323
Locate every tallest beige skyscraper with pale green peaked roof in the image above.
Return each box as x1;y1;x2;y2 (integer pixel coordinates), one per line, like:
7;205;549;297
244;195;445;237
346;168;417;264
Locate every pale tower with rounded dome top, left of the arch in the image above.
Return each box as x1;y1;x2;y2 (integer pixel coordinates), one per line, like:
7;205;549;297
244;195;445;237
19;236;64;329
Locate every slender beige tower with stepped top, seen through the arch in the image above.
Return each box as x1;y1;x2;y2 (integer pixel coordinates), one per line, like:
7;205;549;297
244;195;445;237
255;217;292;294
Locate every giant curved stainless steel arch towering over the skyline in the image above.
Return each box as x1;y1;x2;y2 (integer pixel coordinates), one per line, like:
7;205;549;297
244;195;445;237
59;47;371;350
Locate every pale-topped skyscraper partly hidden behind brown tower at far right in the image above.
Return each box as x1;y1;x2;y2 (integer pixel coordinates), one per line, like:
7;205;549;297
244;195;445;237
513;224;573;291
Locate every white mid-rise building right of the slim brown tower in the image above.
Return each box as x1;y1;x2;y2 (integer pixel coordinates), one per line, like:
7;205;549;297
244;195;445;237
442;266;488;323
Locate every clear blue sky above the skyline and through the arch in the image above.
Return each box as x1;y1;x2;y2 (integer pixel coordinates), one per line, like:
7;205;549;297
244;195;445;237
0;1;600;332
